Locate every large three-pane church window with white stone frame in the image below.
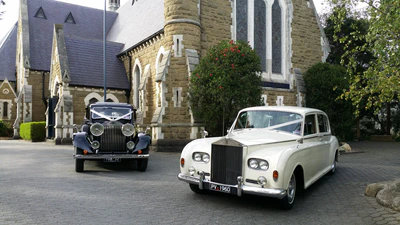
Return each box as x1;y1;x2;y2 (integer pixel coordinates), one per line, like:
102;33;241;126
232;0;291;81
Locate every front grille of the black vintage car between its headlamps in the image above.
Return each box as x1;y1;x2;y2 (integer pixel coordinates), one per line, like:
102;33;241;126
99;124;126;153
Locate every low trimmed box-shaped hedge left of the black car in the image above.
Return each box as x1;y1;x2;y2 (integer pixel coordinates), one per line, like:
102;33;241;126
19;122;46;142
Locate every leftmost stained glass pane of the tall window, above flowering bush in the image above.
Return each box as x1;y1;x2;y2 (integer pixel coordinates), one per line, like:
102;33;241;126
236;0;248;42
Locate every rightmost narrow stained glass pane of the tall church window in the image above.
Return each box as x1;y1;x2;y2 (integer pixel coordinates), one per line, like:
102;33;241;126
272;0;282;74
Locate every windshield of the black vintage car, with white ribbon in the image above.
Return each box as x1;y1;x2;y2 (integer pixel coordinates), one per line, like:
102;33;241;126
91;106;132;120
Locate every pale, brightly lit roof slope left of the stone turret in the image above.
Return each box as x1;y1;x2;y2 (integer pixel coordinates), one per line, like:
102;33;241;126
107;0;165;51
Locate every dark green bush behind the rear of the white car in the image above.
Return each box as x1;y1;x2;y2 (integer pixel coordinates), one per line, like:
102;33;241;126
303;63;355;140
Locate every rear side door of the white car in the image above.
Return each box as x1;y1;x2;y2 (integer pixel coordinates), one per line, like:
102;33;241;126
317;114;334;173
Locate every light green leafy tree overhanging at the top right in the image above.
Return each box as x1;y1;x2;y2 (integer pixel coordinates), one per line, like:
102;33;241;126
332;0;400;117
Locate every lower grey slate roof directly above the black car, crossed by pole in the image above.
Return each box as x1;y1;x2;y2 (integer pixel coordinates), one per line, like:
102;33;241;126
65;37;129;89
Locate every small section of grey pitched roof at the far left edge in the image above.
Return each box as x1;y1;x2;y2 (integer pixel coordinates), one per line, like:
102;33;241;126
0;24;18;81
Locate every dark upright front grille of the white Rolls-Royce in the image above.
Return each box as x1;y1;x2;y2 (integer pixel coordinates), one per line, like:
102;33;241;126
211;144;243;185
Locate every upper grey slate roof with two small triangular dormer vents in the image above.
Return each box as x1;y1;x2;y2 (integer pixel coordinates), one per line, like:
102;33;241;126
27;0;117;71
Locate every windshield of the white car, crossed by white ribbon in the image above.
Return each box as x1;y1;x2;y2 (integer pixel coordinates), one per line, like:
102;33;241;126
234;110;303;135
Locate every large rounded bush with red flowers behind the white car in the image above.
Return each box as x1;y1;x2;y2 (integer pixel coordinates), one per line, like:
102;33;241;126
189;41;262;136
